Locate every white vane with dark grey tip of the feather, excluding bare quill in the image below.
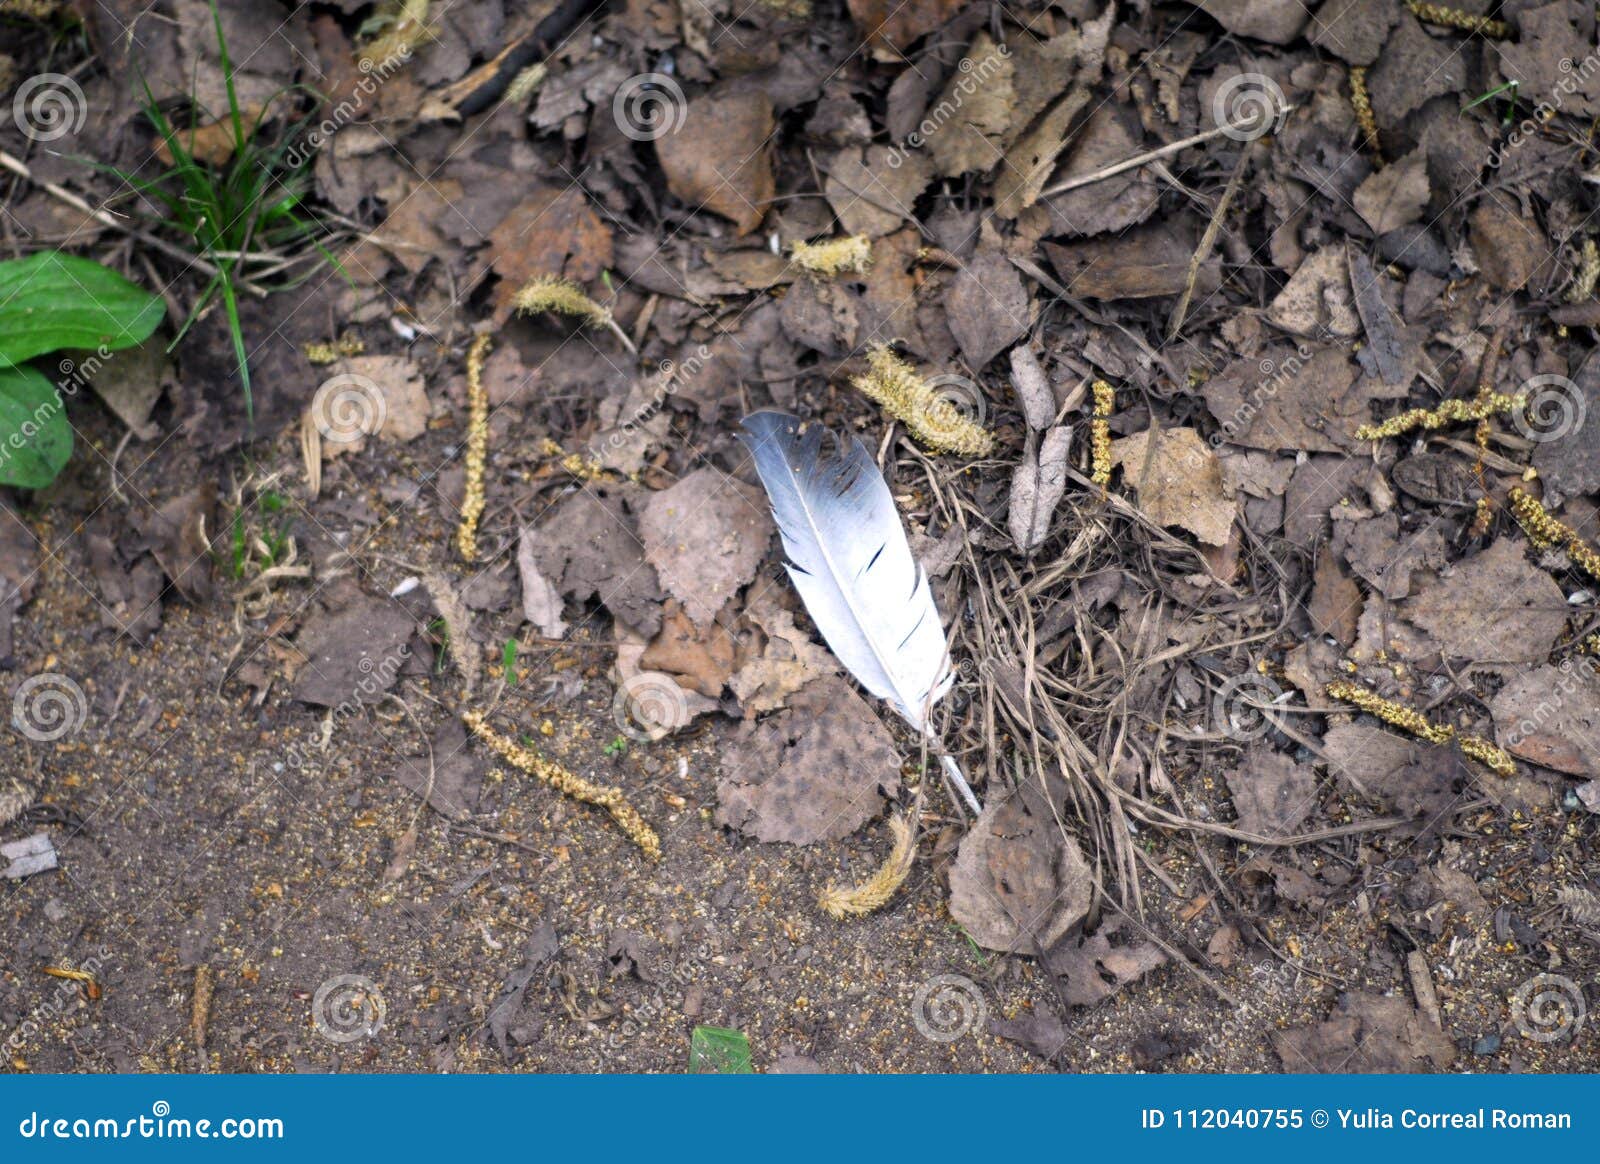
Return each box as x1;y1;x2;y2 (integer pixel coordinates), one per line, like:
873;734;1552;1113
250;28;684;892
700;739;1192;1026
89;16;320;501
741;413;955;732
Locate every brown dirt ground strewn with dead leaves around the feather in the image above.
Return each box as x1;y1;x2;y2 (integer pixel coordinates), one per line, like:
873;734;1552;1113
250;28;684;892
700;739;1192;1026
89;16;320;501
0;0;1600;1071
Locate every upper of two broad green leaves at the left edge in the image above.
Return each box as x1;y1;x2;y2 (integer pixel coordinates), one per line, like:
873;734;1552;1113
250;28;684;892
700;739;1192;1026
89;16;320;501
0;251;166;368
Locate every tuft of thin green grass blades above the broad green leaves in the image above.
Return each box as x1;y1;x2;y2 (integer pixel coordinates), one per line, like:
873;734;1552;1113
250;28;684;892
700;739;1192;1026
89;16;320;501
109;0;344;425
